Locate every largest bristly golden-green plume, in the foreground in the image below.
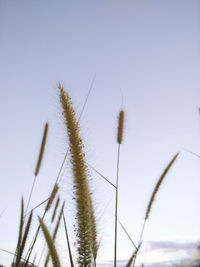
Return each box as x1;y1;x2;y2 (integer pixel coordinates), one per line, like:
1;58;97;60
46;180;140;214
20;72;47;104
58;84;97;267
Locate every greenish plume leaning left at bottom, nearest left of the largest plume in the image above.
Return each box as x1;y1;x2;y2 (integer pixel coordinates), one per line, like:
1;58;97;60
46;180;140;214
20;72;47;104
39;217;61;267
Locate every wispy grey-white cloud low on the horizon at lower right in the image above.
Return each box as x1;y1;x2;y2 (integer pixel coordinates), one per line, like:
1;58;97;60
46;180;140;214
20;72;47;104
98;240;200;267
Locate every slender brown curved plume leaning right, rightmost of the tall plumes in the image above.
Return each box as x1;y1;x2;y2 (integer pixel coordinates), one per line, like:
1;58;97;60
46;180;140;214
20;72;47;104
145;153;179;220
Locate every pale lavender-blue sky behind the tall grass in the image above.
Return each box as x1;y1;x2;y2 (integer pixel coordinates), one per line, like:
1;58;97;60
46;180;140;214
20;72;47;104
0;0;200;267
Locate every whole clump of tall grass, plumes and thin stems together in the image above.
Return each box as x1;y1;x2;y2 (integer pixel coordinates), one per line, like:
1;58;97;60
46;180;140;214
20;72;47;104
1;84;179;267
